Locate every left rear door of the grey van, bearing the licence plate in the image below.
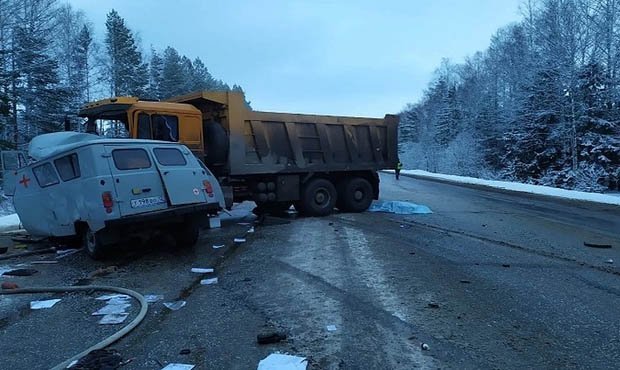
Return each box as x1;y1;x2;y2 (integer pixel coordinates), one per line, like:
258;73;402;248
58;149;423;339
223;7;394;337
105;145;168;216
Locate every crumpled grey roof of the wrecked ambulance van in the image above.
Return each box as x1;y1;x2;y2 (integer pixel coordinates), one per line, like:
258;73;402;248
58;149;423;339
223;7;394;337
28;132;183;161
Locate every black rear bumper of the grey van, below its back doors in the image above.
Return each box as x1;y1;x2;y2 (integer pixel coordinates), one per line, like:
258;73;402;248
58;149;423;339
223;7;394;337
105;203;221;228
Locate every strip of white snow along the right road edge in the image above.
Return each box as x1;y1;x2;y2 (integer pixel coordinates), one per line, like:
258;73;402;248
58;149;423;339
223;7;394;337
401;170;620;205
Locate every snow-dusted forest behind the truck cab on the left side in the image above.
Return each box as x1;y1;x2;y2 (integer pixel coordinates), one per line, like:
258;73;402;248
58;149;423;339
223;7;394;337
0;0;242;148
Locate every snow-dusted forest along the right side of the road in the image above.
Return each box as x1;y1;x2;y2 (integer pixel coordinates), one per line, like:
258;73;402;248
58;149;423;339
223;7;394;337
400;0;620;191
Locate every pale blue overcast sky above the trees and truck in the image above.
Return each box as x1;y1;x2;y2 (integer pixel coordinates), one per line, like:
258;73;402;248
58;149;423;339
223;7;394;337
69;0;521;117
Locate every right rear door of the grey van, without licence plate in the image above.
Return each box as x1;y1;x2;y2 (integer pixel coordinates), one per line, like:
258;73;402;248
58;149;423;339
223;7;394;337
153;146;207;205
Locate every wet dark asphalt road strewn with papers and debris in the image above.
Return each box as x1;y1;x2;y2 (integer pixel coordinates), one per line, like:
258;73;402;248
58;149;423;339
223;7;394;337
0;175;620;369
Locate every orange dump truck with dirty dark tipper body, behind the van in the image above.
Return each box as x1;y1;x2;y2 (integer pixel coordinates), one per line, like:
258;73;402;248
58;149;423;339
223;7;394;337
79;91;399;216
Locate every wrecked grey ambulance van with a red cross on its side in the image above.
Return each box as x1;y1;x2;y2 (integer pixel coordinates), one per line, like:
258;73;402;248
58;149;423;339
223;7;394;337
14;133;224;243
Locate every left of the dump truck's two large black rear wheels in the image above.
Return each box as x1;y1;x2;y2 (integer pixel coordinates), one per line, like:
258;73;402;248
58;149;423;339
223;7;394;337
295;179;338;216
